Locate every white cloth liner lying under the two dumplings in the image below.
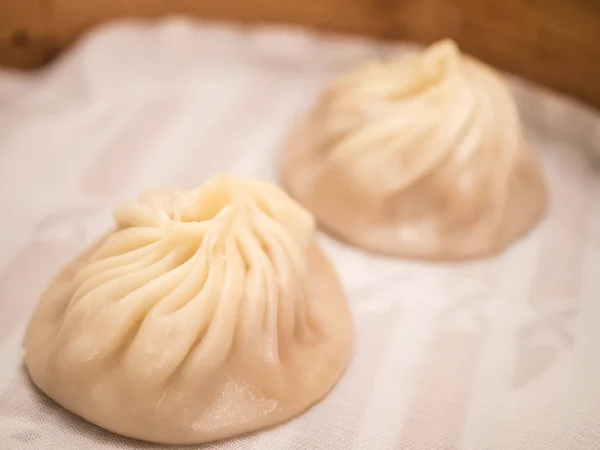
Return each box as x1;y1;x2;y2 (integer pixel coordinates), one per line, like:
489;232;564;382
0;19;600;450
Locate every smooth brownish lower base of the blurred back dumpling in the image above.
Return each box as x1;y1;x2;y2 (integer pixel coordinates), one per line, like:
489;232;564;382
281;125;547;262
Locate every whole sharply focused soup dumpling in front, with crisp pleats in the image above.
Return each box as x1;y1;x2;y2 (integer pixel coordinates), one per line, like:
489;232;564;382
25;175;353;443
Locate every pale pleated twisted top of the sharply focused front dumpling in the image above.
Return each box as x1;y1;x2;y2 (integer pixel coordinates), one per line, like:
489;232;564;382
51;175;314;381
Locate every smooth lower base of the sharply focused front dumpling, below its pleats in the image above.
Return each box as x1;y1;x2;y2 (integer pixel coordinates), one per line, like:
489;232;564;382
25;237;353;444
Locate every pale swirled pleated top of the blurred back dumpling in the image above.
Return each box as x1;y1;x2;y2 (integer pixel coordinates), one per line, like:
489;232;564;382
318;40;524;204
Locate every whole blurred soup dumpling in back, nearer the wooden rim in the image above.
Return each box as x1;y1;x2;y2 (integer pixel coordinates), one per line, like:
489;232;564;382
282;41;546;260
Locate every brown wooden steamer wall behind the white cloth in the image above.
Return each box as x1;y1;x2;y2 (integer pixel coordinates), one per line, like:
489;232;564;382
0;0;600;107
